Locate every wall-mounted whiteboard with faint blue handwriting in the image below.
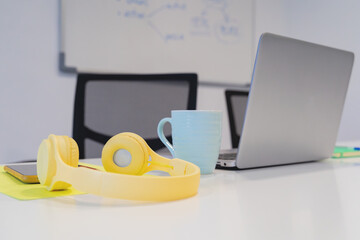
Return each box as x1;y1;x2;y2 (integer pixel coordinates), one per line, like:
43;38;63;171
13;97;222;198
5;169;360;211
61;0;254;84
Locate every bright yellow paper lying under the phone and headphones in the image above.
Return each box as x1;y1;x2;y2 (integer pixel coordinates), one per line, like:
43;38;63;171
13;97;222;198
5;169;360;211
0;163;101;200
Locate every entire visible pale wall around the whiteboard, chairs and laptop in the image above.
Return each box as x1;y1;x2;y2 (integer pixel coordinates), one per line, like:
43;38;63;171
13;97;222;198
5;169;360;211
0;0;360;163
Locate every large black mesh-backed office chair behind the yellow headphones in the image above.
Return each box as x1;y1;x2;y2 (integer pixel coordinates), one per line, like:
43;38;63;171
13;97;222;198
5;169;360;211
73;73;198;158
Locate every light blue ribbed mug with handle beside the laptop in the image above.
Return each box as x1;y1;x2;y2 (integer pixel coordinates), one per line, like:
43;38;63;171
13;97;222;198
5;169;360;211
157;110;222;174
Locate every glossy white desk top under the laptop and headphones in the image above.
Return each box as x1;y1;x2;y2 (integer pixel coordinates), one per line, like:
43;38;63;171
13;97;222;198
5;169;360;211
0;159;360;240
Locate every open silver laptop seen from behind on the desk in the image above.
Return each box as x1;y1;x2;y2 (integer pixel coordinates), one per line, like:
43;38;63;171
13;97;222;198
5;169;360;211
218;33;354;169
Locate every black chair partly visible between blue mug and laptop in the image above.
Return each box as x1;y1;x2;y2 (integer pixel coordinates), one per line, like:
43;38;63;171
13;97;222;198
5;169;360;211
225;90;249;148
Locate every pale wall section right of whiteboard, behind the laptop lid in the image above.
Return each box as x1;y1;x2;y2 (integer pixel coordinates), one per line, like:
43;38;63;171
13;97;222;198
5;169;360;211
256;0;360;141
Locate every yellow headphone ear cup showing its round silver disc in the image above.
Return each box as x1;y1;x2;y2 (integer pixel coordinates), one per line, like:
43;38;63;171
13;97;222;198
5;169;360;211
101;133;149;175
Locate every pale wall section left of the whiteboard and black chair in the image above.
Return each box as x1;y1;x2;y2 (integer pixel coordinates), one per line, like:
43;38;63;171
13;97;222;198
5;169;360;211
0;0;75;163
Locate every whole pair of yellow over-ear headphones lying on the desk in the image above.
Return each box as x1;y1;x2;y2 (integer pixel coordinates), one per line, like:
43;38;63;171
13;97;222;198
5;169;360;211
37;132;200;201
